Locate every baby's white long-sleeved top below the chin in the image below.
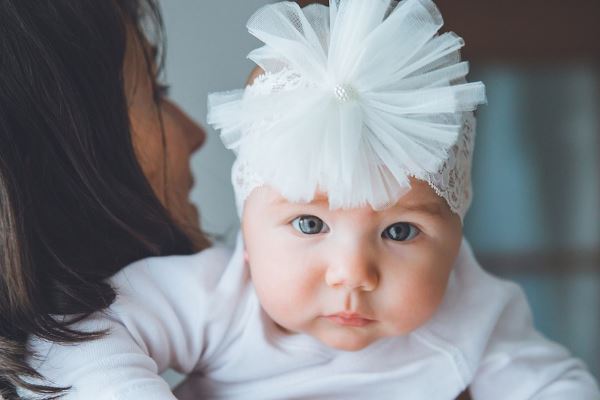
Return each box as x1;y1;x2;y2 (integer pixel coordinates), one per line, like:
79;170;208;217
25;236;600;400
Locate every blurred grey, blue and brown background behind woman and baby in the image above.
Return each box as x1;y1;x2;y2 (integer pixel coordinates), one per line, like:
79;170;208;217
161;0;600;379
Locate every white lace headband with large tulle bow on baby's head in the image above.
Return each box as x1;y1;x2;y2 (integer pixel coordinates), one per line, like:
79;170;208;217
208;0;485;218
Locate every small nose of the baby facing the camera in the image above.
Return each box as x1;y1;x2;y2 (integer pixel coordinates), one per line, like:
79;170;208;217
325;246;379;292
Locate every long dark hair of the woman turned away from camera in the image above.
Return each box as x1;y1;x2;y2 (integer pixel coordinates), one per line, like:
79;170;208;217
0;0;204;399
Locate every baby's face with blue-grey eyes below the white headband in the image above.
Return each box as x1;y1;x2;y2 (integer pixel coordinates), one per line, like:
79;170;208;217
242;180;462;351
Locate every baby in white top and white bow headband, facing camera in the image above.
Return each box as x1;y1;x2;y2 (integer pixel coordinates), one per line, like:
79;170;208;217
24;0;600;400
